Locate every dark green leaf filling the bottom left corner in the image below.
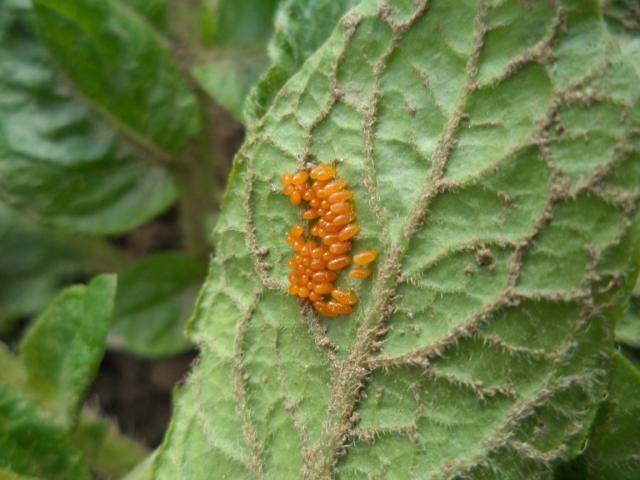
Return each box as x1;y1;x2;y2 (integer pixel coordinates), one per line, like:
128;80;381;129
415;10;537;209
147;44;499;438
0;383;90;480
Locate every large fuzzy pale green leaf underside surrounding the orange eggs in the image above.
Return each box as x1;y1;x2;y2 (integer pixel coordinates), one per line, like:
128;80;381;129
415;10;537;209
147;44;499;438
154;0;640;480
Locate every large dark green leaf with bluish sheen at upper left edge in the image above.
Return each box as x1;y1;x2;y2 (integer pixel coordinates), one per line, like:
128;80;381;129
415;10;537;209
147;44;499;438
0;0;175;234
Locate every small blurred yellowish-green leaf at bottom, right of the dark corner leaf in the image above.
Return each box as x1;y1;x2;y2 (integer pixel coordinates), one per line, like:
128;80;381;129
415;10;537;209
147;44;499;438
73;408;149;480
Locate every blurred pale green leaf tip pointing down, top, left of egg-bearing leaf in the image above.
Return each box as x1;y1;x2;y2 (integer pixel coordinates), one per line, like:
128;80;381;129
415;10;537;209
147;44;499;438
191;0;278;121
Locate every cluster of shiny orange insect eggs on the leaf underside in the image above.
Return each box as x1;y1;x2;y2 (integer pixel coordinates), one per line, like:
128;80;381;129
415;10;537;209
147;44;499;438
282;164;377;317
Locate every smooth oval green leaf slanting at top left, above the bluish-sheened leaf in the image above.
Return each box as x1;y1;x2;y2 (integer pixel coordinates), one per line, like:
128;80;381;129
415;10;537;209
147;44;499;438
34;0;199;157
